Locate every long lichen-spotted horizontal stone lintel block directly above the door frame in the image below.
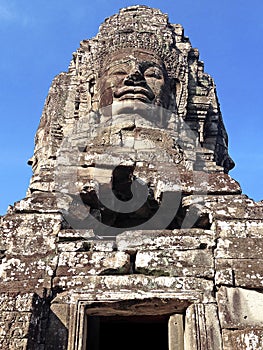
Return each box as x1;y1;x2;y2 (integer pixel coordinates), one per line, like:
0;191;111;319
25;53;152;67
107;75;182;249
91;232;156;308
54;275;214;303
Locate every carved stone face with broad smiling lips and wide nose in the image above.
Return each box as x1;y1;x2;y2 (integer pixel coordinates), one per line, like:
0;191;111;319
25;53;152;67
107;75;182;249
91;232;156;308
98;50;171;108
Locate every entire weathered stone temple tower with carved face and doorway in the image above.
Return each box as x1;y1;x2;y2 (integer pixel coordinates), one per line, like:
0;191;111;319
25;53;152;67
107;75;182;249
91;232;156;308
0;6;263;350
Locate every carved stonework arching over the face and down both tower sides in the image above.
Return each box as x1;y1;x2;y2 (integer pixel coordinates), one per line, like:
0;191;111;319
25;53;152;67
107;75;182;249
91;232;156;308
30;6;234;198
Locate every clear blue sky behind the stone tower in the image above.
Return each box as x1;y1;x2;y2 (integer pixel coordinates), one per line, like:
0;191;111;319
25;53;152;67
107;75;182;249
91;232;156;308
0;0;263;214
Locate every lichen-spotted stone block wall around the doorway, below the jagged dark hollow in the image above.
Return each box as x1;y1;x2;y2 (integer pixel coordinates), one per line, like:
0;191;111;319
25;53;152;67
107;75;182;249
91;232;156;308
0;195;263;350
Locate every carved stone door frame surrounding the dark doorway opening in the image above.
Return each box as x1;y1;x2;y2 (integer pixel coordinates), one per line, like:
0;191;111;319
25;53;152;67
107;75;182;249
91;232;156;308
68;297;189;350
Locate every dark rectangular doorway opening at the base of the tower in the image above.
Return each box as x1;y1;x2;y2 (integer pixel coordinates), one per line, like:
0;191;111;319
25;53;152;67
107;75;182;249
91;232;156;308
86;316;169;350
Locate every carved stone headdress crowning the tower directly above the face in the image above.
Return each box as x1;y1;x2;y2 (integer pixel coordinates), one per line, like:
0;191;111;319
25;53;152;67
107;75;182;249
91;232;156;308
72;6;186;77
